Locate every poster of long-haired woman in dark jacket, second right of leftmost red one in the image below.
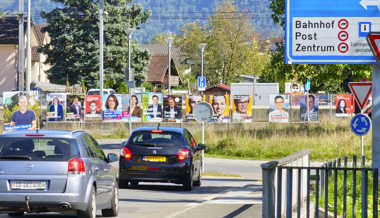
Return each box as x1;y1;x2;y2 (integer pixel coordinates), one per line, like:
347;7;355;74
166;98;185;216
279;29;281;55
123;94;143;122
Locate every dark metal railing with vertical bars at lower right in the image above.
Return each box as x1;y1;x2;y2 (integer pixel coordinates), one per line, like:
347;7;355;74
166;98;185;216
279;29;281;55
270;156;379;218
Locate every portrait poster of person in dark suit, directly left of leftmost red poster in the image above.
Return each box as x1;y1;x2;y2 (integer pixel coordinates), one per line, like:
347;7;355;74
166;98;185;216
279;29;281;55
66;94;86;122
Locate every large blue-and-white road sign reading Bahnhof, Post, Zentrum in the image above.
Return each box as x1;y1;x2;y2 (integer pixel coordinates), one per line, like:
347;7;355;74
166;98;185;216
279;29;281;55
285;0;380;64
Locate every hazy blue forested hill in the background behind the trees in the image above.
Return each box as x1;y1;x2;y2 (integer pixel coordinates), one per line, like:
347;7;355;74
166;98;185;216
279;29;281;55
0;0;284;44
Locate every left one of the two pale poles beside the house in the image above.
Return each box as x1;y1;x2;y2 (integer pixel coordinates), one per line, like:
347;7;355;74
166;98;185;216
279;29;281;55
17;0;25;91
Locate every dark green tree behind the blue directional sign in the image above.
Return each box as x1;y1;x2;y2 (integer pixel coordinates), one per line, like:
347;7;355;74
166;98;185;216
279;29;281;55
265;0;372;93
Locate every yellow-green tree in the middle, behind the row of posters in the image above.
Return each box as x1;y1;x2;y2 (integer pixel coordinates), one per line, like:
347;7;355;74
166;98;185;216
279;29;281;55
178;2;254;85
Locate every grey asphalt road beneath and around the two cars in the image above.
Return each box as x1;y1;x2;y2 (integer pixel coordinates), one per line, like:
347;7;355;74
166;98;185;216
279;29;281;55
0;140;262;218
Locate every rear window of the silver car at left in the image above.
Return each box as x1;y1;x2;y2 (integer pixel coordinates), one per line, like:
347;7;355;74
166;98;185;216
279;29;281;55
0;137;79;161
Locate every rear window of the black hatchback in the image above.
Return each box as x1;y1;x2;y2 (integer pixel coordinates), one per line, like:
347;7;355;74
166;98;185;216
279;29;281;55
128;131;184;147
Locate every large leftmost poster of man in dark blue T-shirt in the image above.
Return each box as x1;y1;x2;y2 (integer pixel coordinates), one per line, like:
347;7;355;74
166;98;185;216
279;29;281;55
3;91;39;130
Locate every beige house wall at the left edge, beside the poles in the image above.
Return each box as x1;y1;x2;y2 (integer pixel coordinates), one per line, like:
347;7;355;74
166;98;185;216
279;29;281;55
0;45;17;95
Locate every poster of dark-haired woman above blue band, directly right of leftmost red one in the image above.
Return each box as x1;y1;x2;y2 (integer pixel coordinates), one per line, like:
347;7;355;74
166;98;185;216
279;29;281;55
102;94;122;121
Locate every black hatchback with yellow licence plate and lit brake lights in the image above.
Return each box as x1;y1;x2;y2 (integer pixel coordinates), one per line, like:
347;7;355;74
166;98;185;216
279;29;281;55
119;126;206;191
